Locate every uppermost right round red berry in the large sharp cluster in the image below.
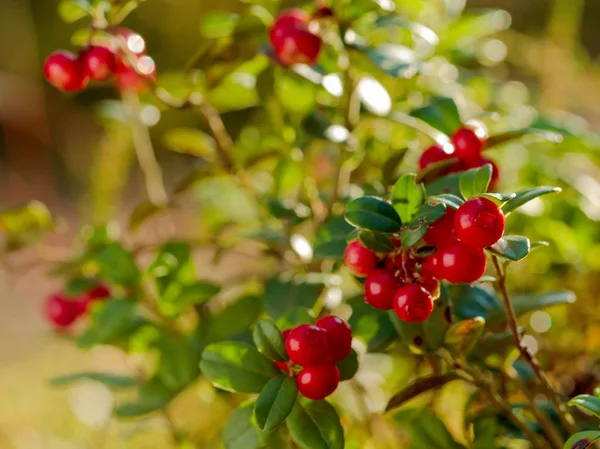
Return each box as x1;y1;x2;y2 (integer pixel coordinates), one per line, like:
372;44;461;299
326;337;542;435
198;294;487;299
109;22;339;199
454;198;505;248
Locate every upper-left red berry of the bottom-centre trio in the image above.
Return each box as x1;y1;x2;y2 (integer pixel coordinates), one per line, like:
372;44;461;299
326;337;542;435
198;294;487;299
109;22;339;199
285;324;330;366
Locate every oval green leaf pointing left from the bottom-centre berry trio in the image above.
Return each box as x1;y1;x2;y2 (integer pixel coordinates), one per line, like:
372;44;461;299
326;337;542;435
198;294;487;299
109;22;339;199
200;342;280;393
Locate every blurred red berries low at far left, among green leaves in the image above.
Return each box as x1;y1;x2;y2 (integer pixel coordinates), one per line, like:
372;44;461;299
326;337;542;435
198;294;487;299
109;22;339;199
45;284;110;330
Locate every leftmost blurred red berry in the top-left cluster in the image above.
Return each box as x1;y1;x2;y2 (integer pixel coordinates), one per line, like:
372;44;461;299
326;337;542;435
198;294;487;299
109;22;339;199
44;50;89;92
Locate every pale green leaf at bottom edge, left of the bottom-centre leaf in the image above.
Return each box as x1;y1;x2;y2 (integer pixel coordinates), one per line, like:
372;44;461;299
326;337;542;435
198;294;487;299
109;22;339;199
223;401;269;449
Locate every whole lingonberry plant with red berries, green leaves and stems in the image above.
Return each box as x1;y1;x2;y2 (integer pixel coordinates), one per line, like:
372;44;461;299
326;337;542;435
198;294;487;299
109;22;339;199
0;0;600;449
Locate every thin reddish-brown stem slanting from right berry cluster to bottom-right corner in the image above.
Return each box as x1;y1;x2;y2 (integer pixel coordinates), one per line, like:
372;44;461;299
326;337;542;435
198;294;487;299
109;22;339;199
492;256;577;433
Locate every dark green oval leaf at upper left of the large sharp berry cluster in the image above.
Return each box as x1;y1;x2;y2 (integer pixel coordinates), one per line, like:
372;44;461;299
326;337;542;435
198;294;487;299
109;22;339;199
345;196;402;232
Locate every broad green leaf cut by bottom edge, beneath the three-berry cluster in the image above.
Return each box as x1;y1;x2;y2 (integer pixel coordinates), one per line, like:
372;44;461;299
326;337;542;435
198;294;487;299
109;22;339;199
286;399;344;449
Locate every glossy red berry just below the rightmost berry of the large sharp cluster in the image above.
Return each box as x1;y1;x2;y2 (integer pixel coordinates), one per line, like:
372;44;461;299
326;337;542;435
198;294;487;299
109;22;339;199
438;242;487;284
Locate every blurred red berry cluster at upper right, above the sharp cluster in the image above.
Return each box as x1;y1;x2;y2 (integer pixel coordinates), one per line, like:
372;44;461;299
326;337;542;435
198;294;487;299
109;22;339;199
419;126;500;190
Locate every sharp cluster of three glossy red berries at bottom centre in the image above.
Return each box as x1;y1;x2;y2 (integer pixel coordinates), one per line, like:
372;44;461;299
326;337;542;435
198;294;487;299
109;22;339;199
274;315;352;401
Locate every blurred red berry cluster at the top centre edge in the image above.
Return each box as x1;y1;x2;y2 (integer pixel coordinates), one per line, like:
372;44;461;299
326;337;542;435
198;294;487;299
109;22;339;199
269;8;322;66
